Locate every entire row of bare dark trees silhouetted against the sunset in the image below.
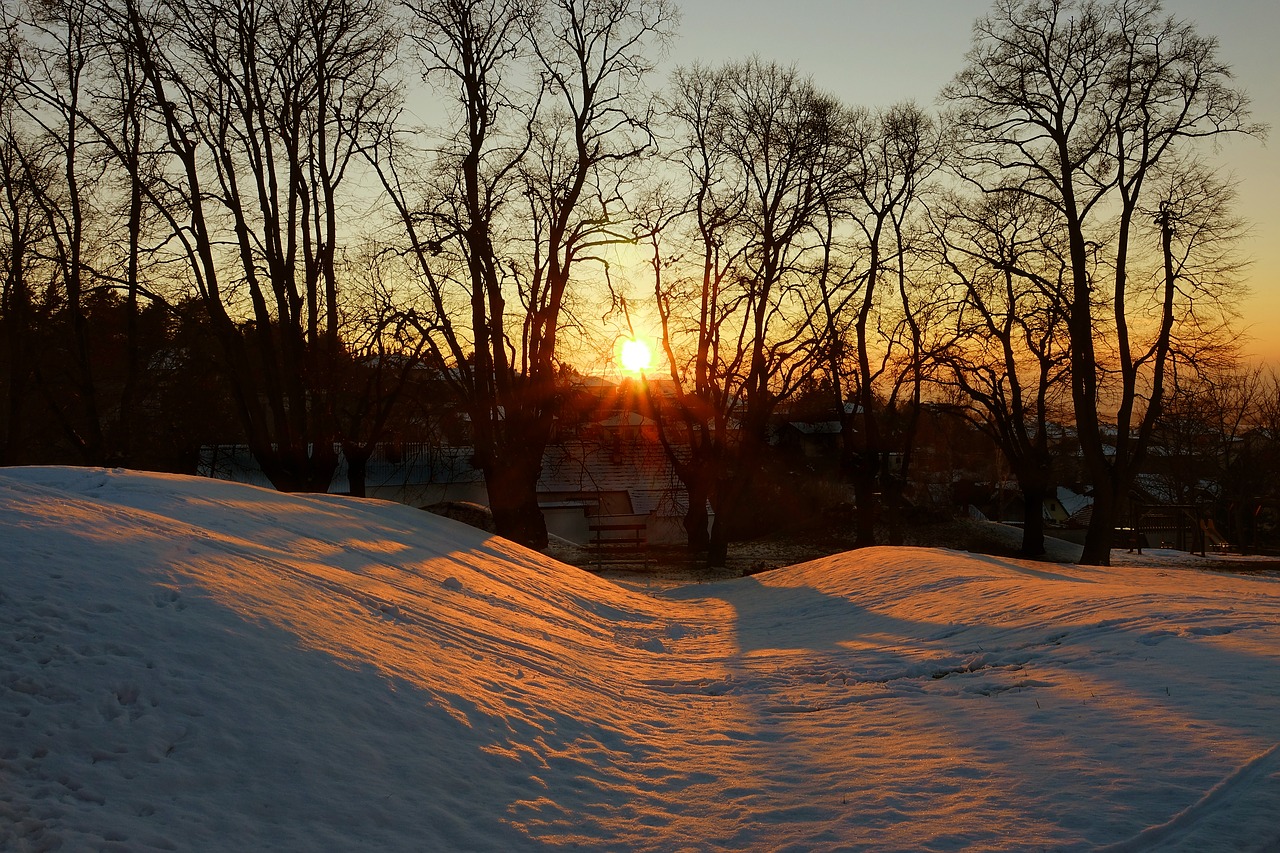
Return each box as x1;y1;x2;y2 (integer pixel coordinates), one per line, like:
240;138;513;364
0;0;1265;564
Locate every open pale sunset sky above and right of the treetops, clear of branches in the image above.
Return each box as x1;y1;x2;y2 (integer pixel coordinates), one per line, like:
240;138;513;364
668;0;1280;365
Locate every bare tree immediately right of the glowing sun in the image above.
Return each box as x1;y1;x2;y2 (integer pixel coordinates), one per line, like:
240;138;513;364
654;60;849;565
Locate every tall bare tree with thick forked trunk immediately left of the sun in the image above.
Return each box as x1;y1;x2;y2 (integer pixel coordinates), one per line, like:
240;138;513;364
384;0;675;547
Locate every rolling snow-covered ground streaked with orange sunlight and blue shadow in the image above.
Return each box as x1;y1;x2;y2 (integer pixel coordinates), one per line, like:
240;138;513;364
0;467;1280;850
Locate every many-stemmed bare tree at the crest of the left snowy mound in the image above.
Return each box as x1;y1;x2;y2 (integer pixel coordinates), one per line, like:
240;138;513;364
102;0;394;491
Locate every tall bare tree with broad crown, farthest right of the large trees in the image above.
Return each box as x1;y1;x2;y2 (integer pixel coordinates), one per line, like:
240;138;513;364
945;0;1256;565
